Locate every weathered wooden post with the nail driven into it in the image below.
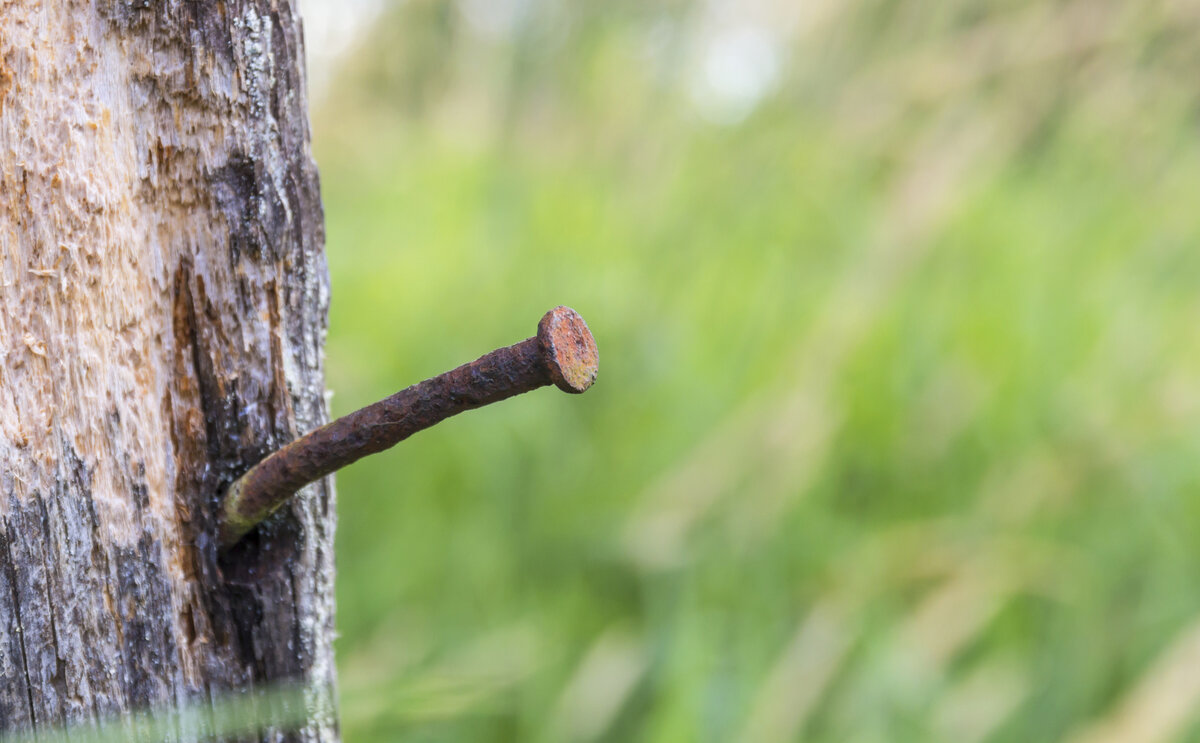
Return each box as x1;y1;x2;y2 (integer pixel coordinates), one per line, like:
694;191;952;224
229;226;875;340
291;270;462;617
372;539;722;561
0;0;337;741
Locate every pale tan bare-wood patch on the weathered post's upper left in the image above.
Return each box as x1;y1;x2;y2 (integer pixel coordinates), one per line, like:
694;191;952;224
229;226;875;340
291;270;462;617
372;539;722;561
0;0;174;535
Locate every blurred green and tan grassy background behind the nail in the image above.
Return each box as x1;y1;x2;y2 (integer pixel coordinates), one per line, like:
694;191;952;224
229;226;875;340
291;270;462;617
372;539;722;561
297;0;1200;743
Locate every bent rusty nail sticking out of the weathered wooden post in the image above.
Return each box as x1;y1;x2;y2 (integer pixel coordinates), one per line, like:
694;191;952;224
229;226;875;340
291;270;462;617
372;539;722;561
220;306;600;549
